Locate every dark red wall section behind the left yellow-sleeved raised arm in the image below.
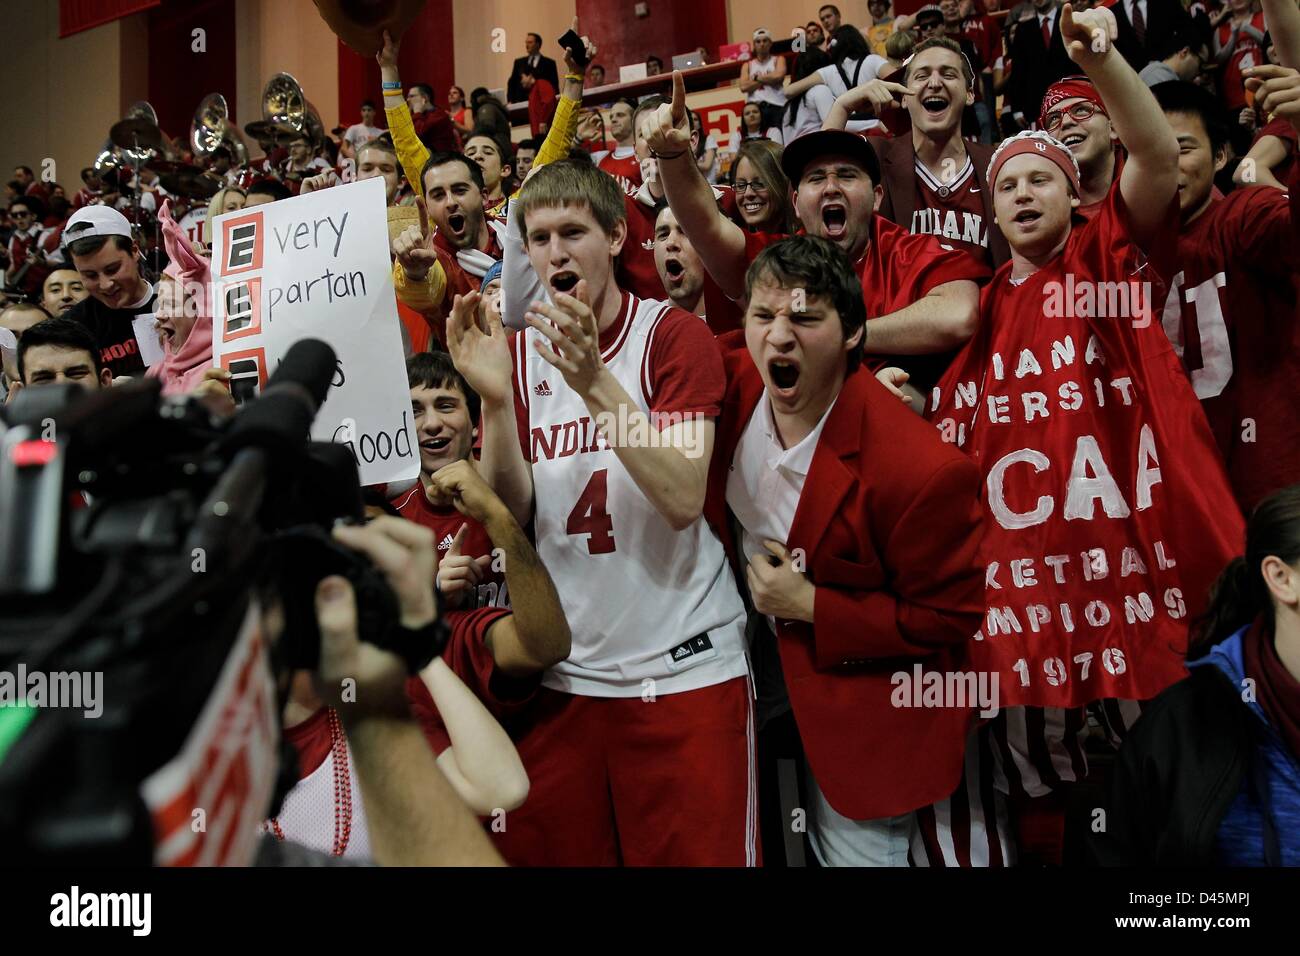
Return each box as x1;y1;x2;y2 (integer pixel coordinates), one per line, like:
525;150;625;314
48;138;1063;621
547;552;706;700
338;0;456;126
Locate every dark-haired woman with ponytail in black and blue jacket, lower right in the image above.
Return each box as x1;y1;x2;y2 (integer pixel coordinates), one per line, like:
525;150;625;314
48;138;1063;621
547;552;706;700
1093;484;1300;866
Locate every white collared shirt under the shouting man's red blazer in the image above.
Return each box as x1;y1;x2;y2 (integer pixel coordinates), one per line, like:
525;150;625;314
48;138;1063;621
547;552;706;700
727;392;839;587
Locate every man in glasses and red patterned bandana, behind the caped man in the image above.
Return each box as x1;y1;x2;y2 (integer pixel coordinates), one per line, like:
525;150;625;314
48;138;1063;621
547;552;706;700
1039;77;1123;219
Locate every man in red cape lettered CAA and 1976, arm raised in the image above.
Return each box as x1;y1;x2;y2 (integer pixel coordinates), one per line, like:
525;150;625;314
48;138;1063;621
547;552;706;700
928;4;1243;862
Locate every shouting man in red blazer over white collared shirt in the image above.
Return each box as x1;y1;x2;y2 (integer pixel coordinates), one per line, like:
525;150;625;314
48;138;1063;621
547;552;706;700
706;237;983;866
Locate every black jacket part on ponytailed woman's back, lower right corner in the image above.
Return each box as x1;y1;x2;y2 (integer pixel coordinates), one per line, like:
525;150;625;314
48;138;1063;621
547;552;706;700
1089;666;1255;866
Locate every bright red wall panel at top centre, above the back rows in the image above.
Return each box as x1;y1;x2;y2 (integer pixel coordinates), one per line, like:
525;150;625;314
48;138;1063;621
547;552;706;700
579;0;727;83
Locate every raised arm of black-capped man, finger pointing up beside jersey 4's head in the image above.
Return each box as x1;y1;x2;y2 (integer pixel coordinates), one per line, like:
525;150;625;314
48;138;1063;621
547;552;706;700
644;70;746;299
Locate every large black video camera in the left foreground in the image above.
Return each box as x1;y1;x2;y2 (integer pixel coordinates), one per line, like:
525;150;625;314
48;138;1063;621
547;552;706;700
0;339;441;866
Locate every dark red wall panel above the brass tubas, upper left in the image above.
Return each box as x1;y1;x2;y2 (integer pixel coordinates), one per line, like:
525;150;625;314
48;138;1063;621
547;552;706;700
148;0;235;142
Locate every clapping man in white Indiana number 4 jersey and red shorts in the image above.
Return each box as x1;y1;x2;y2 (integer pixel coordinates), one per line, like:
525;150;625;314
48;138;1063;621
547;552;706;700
447;160;758;866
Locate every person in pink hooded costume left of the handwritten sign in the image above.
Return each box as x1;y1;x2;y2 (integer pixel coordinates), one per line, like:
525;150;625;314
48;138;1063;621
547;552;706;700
146;202;226;395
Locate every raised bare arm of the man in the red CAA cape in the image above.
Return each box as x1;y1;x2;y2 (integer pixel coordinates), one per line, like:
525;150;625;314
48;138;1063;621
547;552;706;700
1061;4;1178;246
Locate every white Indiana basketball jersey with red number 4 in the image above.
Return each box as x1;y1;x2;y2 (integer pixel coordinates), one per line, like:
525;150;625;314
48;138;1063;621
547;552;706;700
515;293;749;697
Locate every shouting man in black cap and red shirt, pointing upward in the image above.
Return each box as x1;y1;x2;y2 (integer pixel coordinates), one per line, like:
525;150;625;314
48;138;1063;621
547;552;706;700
649;75;989;400
